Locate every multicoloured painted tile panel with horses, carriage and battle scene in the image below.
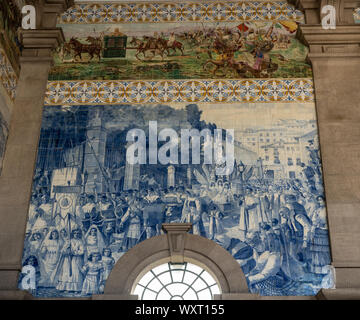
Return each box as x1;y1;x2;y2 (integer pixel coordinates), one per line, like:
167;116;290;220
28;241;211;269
49;20;312;80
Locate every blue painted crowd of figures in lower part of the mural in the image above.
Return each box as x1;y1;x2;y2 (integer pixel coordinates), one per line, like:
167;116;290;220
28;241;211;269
19;137;330;296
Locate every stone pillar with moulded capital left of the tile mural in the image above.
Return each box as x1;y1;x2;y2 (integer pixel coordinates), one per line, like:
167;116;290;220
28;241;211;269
0;0;70;299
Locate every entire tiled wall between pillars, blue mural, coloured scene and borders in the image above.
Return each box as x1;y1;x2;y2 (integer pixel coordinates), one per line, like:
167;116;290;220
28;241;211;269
19;2;333;297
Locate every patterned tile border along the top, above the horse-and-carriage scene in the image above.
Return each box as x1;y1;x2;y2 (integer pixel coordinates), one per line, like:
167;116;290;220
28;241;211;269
59;1;304;24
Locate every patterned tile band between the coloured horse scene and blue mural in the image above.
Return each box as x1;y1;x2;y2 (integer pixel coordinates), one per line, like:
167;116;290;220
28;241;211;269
45;79;314;105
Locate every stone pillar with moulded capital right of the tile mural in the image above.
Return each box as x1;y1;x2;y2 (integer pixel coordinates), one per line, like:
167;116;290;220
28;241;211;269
298;0;360;299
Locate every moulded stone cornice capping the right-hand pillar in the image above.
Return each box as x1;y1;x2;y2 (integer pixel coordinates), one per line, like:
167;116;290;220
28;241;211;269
299;25;360;60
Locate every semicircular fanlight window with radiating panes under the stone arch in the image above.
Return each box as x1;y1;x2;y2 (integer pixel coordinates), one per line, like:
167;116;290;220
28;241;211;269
132;263;221;300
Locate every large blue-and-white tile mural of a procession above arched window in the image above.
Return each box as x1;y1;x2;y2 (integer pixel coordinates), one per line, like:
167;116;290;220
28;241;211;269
19;103;333;297
